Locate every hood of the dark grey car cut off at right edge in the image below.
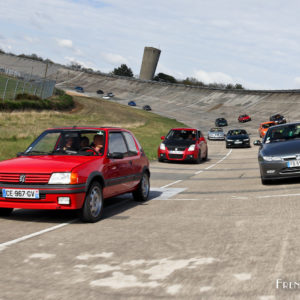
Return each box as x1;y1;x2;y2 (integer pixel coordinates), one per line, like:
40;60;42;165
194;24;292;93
260;140;300;156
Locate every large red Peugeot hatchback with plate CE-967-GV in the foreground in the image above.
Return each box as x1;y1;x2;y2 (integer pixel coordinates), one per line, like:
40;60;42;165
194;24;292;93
0;126;150;222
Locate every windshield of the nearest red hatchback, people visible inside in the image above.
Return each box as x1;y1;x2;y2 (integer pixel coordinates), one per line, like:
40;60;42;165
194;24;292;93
23;130;105;155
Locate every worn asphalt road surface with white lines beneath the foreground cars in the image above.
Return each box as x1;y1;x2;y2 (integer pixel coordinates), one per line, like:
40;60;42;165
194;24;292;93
0;141;300;300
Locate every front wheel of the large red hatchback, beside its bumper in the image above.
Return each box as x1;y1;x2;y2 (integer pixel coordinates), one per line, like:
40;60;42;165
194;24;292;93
79;181;103;223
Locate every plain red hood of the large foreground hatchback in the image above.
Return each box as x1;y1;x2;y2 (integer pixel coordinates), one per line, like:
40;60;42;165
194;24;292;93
0;155;97;174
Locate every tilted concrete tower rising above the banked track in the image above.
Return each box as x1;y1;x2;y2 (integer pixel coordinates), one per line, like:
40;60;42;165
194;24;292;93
140;47;161;80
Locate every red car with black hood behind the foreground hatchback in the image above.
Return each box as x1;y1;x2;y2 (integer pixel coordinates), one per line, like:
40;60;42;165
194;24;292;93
157;128;208;163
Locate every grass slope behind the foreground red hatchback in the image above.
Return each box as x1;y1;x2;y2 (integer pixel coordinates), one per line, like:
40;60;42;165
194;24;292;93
0;97;185;160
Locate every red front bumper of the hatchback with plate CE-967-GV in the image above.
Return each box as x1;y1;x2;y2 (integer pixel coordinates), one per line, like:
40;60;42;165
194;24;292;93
0;184;85;210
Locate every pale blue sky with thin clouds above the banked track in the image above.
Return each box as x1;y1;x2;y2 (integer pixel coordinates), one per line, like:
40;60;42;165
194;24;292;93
0;0;300;89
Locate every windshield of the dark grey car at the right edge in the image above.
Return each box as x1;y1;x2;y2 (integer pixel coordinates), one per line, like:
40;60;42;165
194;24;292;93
265;124;300;143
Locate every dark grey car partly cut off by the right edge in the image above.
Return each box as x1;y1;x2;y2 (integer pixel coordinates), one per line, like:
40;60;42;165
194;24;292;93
258;122;300;184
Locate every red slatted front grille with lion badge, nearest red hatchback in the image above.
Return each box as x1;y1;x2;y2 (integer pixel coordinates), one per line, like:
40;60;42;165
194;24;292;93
0;173;51;184
